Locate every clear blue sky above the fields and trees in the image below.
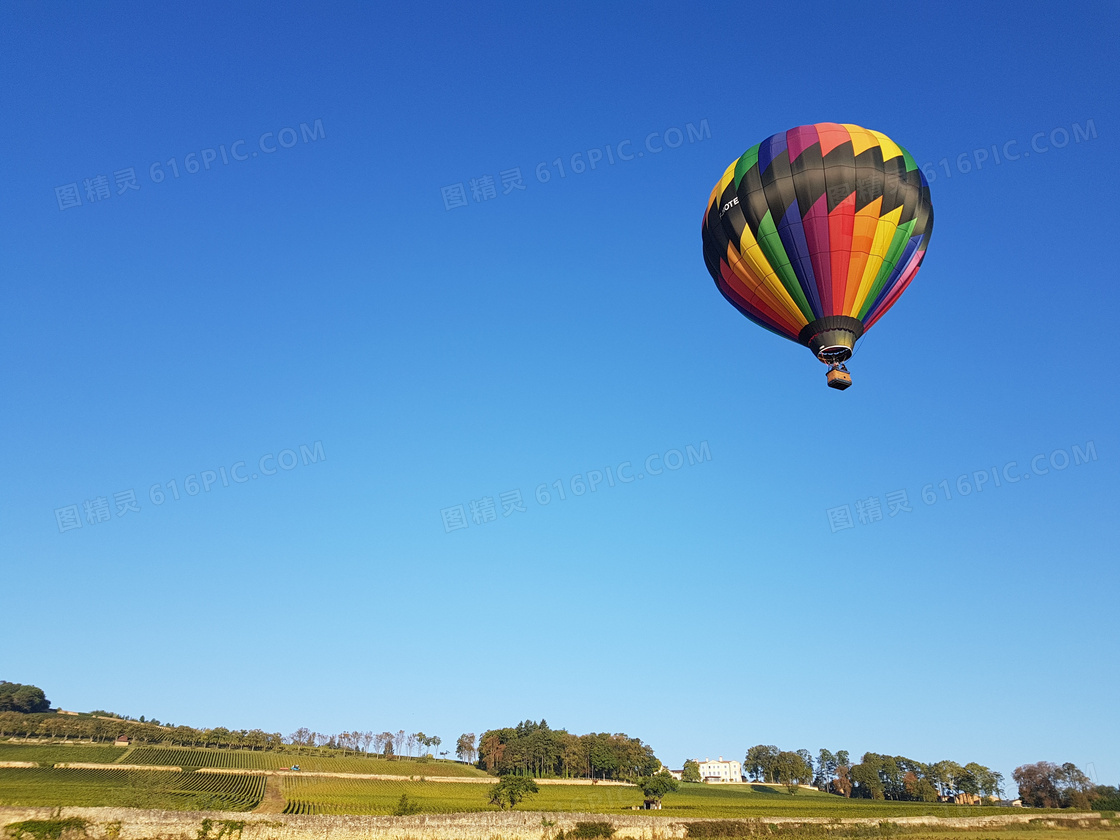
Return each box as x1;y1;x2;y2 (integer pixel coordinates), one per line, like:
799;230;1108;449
0;2;1120;784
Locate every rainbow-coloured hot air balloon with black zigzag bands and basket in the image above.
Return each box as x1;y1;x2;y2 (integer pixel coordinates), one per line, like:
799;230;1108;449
702;122;933;391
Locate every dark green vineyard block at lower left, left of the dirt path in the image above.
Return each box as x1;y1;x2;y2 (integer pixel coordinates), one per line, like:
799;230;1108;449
0;768;264;811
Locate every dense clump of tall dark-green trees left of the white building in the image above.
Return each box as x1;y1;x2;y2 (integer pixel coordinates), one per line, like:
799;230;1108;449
478;720;661;780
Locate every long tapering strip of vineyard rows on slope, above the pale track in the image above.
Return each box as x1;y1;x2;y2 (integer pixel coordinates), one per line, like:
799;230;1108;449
123;747;486;778
